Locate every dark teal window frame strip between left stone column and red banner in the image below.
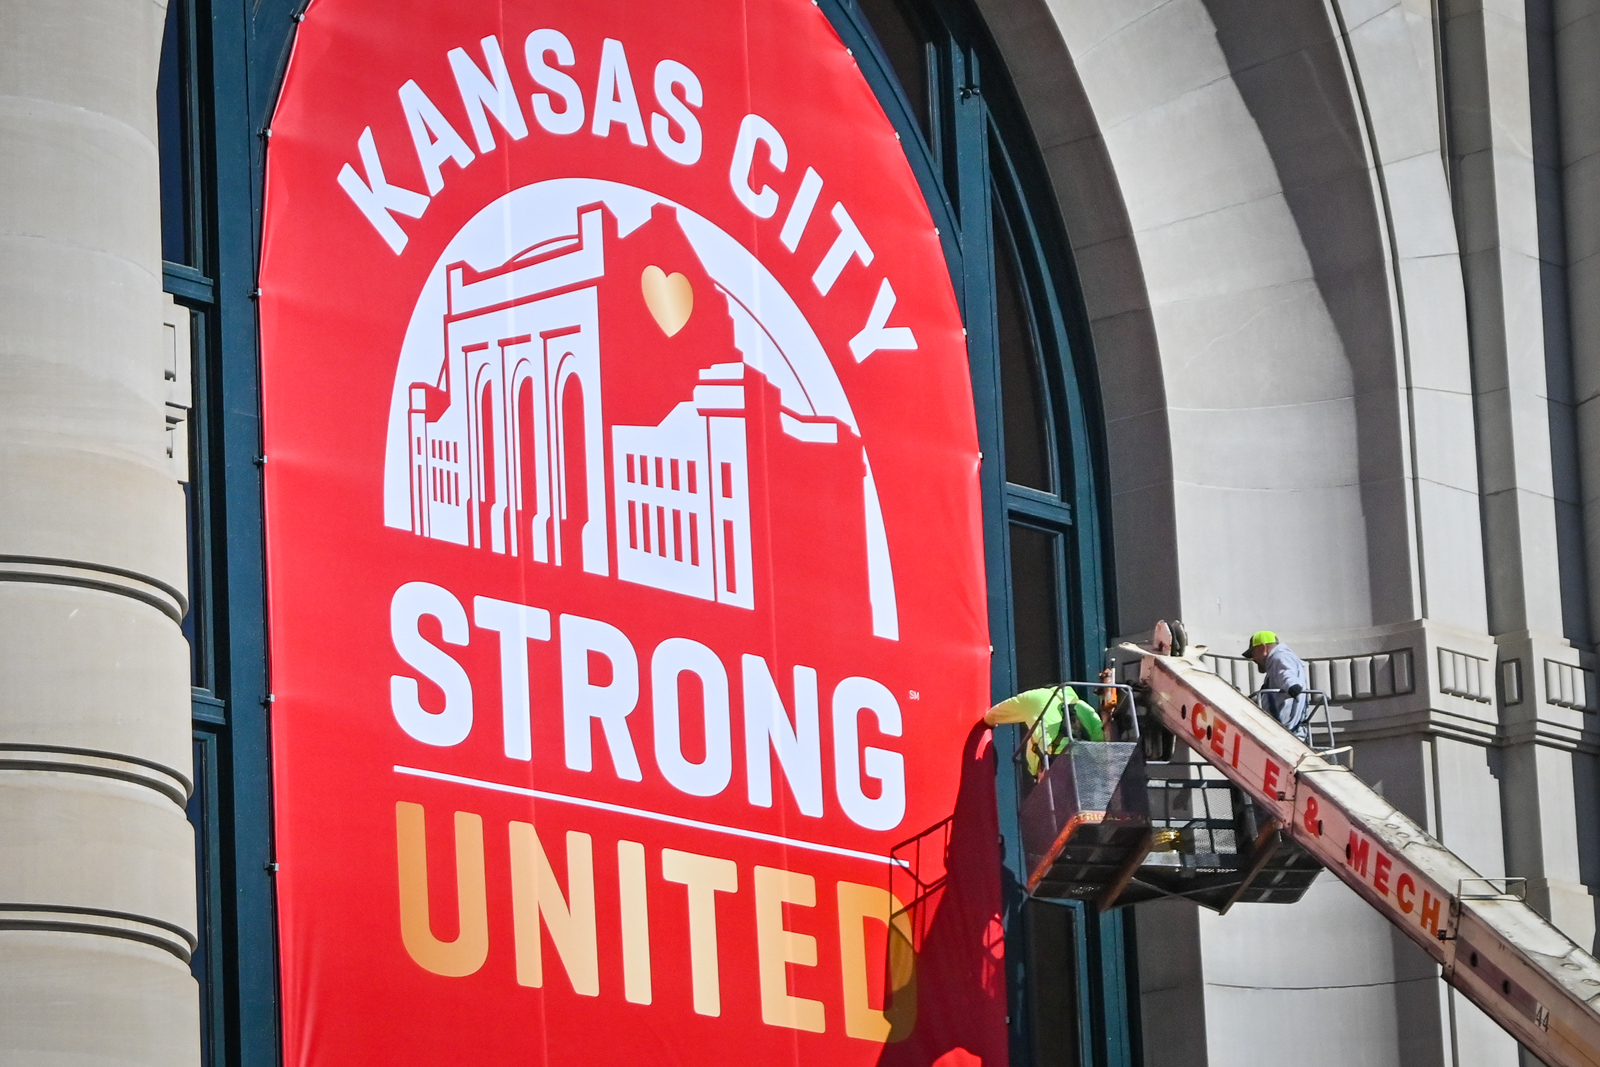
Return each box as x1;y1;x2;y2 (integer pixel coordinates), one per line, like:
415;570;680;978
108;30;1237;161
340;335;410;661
157;0;301;1067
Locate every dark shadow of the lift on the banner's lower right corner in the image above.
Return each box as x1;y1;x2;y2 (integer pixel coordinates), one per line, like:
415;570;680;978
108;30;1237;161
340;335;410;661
878;723;1008;1067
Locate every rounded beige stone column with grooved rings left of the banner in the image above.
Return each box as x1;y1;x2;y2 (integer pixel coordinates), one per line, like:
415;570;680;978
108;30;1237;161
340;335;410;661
0;0;200;1067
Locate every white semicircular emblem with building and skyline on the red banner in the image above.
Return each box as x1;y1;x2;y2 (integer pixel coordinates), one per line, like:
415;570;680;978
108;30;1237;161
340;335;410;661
384;178;899;640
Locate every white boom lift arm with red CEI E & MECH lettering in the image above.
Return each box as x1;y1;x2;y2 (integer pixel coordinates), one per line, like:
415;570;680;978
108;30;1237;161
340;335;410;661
1122;645;1600;1067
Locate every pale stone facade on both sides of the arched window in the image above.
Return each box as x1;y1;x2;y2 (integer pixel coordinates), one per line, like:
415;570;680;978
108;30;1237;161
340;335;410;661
0;0;1600;1067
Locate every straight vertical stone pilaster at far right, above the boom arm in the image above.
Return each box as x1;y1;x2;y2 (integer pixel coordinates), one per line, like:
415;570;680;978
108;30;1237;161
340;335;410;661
1442;0;1595;949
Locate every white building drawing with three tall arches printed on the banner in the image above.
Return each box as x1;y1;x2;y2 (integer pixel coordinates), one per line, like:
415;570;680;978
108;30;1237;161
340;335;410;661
410;208;755;608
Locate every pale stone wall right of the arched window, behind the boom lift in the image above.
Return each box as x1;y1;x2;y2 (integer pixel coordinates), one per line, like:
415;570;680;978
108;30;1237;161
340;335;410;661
979;0;1600;1067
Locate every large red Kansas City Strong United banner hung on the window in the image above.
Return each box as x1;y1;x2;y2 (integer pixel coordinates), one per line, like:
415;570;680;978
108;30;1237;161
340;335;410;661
261;0;1005;1065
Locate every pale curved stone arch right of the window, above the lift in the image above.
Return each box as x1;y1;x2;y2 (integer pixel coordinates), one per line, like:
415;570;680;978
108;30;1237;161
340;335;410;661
979;0;1475;633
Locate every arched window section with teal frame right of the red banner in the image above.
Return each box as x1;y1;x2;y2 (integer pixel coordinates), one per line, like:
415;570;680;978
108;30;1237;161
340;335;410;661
824;0;1138;1067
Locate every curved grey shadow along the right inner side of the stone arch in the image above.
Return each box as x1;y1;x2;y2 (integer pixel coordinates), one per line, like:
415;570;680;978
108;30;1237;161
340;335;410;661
1203;0;1413;625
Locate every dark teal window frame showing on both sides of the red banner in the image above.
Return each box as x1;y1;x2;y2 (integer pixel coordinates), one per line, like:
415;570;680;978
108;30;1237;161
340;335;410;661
160;0;1142;1067
